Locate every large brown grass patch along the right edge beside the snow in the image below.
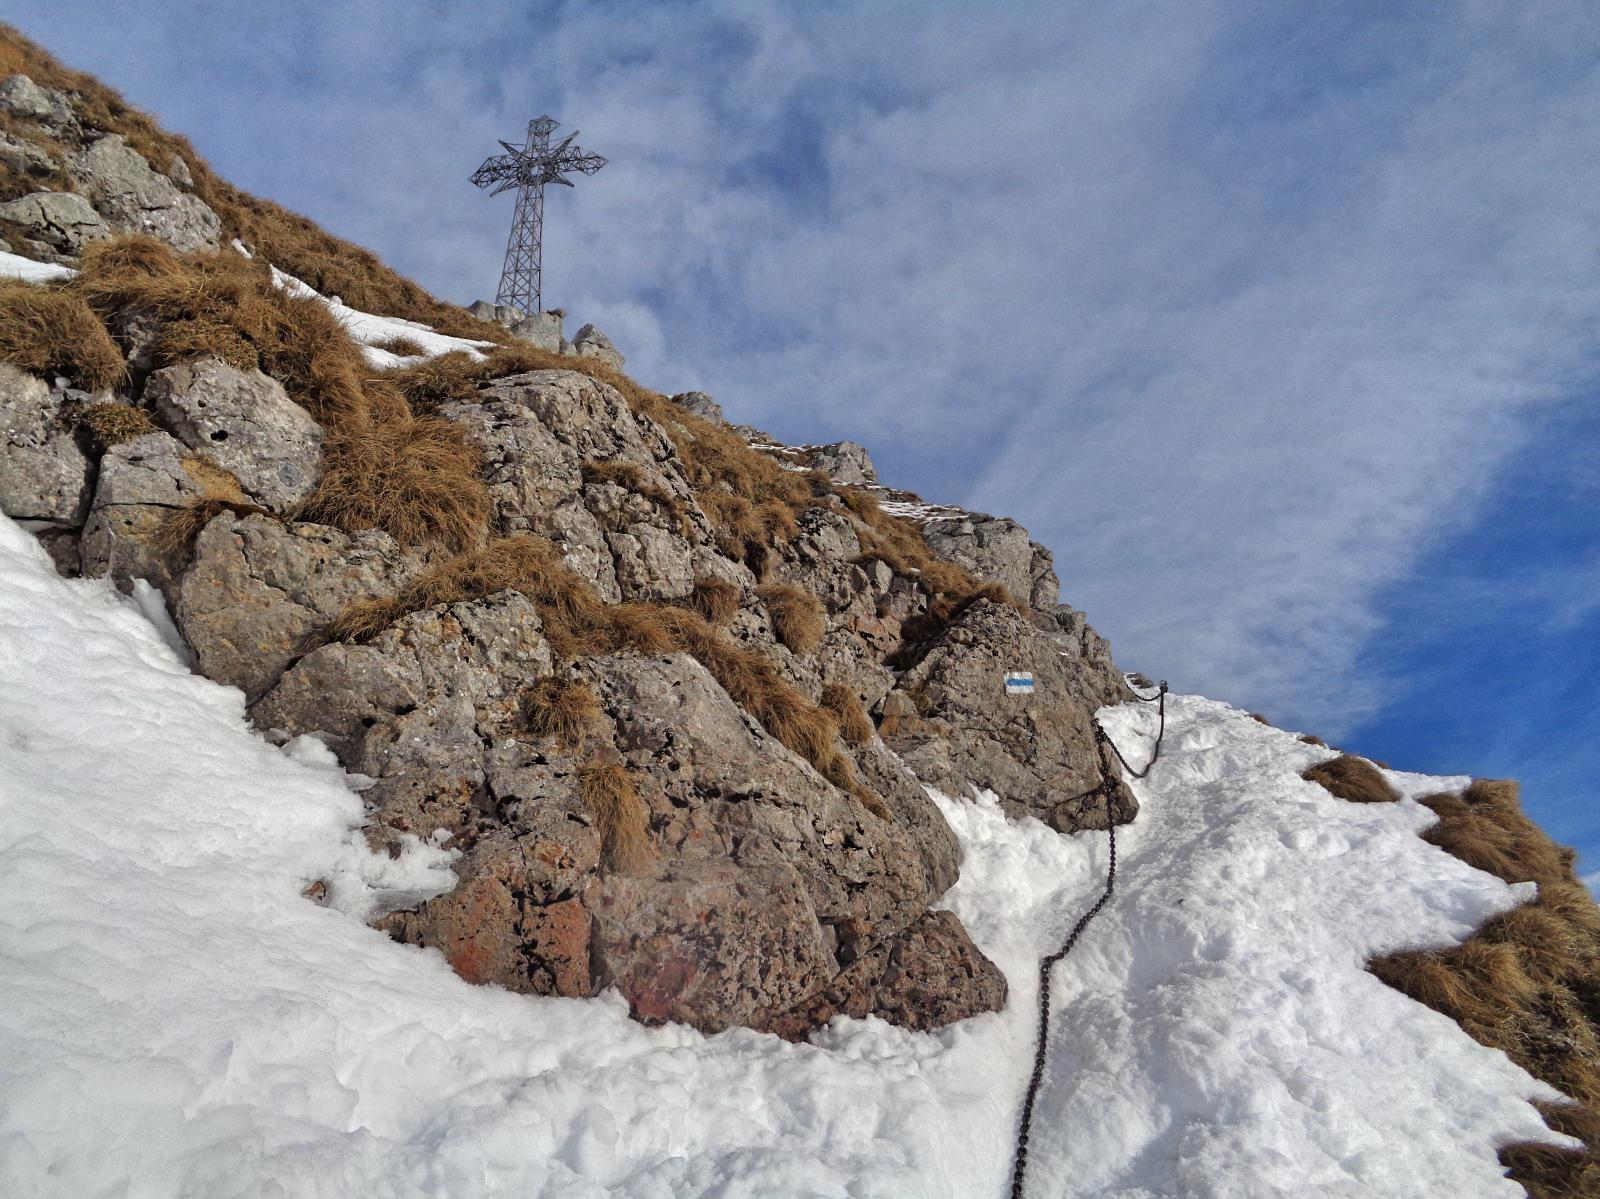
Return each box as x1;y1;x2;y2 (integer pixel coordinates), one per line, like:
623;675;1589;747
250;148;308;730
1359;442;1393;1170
1368;780;1600;1199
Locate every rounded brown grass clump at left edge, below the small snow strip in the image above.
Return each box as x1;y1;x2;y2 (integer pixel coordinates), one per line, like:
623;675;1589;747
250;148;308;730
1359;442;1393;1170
0;280;128;391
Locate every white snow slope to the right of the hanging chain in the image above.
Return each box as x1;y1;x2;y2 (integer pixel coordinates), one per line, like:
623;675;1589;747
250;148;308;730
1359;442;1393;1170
953;696;1568;1199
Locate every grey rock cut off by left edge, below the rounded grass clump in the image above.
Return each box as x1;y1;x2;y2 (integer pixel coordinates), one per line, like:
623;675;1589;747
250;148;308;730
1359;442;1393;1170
0;363;90;528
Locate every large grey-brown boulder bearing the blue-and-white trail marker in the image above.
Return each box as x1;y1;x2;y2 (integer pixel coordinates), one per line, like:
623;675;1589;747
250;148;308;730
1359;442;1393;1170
880;600;1138;831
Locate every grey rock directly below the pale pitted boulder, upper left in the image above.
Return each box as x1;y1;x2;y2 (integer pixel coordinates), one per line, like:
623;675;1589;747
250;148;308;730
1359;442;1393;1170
82;432;216;591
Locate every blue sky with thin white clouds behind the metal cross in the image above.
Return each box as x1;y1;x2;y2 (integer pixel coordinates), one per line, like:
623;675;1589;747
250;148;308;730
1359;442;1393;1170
12;0;1600;869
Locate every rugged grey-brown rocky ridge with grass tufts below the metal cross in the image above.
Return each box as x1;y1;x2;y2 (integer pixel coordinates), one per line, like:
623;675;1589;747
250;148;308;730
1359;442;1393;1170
0;63;1134;1036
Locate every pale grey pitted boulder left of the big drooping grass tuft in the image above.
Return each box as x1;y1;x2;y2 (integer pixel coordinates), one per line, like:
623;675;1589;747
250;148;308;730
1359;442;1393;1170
144;355;323;511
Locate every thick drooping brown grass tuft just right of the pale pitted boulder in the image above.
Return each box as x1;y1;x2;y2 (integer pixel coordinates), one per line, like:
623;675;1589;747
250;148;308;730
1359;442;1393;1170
299;416;490;549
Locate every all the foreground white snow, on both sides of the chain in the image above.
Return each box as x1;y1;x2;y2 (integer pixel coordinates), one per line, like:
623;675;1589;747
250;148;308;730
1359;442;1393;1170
0;517;1574;1199
